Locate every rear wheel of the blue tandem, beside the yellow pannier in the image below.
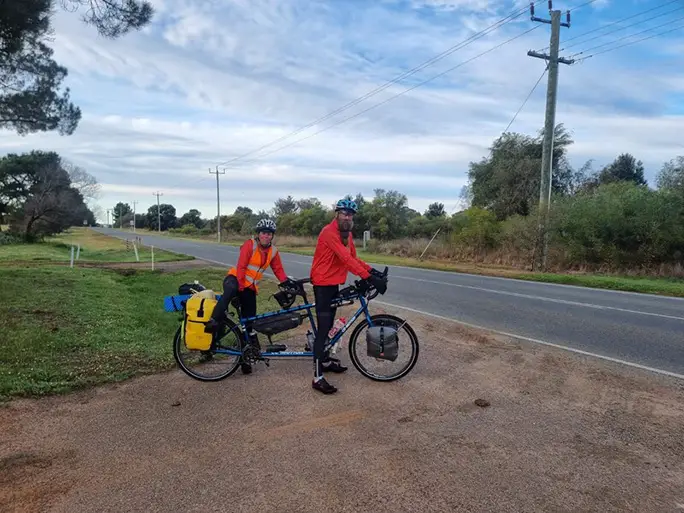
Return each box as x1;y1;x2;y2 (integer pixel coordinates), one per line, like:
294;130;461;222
173;319;242;381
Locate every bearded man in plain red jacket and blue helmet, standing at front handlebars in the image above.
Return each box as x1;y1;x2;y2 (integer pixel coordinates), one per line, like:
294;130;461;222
311;199;386;394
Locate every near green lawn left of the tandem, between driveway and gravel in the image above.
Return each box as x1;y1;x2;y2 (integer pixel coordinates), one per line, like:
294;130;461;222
0;266;284;401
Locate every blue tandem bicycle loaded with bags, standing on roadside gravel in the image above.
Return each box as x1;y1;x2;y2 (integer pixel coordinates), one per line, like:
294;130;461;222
164;267;419;381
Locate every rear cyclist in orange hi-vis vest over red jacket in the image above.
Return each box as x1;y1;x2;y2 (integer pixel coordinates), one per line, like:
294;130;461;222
205;219;290;374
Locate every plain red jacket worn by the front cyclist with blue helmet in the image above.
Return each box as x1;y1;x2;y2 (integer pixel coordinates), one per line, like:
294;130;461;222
310;219;371;285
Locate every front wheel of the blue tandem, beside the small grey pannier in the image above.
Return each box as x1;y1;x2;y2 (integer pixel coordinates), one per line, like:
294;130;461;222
349;314;420;381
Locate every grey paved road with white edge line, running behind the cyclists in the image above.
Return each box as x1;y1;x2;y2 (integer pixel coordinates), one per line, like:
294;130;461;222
99;228;684;378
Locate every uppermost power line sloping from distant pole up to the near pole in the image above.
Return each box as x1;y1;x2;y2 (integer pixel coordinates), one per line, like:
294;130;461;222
219;0;548;165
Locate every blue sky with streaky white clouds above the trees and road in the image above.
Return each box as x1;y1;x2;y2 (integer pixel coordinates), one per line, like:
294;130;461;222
0;0;684;221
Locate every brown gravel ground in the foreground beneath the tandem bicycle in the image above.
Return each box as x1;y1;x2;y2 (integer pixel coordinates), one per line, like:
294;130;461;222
0;307;684;513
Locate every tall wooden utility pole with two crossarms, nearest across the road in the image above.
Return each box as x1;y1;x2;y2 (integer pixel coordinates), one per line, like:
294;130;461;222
527;0;575;271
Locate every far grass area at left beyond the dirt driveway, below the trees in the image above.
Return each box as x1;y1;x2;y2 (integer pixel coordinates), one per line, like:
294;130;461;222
0;227;194;265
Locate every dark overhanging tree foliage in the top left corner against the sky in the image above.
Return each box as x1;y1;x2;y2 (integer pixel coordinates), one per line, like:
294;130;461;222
0;0;153;135
